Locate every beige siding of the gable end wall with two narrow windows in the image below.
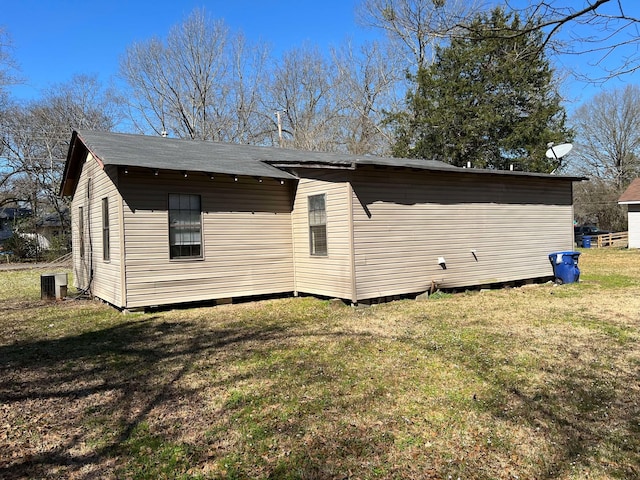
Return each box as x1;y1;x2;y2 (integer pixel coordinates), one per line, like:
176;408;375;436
71;154;123;306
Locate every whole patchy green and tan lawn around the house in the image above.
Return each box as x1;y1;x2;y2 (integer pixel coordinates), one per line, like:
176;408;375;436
0;249;640;479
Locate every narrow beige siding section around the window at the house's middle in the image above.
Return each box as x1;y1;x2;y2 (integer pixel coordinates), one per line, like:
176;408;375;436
292;172;353;299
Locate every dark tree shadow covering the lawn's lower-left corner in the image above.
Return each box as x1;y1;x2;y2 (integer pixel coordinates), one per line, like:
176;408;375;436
0;317;298;479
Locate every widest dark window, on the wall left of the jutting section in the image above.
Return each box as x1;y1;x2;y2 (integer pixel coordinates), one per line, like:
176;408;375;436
169;193;202;259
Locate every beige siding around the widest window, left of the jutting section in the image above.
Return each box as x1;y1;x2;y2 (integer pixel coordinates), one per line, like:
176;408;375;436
120;169;294;308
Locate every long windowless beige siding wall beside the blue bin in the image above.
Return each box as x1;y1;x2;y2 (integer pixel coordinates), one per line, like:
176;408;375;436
353;169;573;300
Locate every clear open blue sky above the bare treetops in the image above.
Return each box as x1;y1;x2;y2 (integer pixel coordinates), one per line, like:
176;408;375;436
0;0;640;110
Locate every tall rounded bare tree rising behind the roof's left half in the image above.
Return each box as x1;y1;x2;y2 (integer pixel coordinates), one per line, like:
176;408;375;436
120;10;228;140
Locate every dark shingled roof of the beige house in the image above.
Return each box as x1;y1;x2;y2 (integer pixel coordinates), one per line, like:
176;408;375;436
60;130;584;195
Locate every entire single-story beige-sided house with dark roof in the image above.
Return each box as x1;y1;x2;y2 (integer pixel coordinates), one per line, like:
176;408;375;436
61;131;581;309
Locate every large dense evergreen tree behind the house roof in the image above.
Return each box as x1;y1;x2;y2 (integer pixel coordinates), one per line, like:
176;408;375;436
390;8;570;172
